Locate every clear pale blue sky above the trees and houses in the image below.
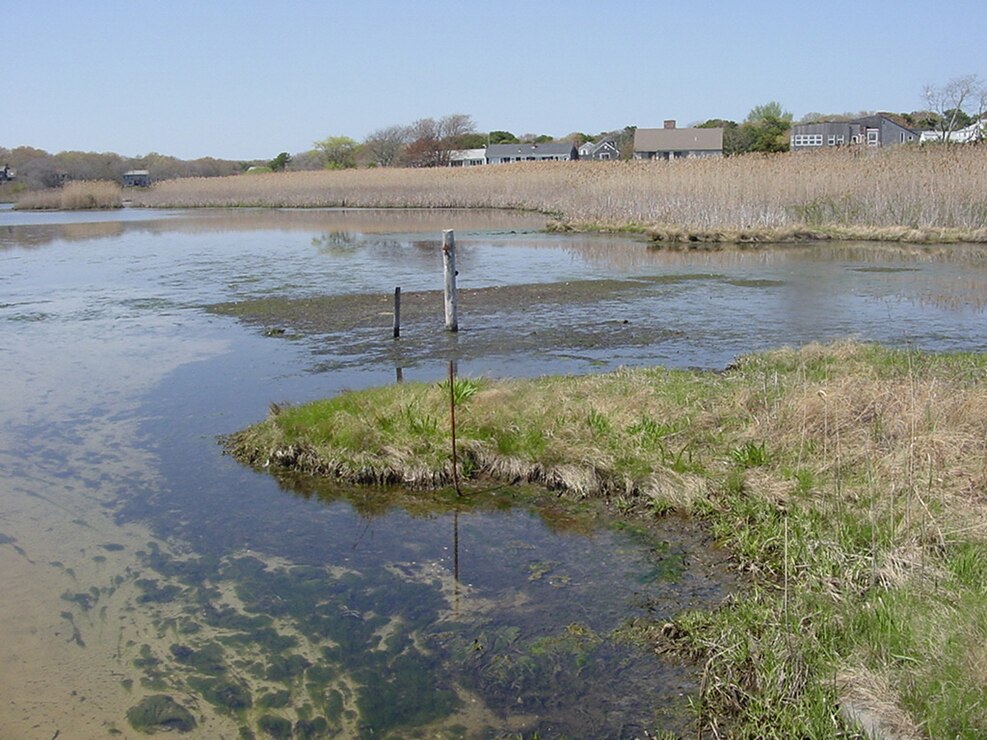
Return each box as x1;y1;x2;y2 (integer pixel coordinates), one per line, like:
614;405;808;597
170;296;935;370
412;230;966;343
0;0;987;159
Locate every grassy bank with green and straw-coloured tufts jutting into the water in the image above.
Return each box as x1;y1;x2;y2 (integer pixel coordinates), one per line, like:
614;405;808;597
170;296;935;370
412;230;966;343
227;343;987;737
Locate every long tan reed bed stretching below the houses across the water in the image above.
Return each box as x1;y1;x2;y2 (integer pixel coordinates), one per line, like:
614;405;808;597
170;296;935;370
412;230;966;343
134;147;987;241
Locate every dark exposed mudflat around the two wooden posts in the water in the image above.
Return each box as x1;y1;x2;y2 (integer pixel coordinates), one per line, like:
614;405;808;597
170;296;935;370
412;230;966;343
208;275;709;369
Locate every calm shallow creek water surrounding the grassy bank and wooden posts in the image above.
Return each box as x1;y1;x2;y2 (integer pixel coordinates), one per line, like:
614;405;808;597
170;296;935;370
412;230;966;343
0;205;987;738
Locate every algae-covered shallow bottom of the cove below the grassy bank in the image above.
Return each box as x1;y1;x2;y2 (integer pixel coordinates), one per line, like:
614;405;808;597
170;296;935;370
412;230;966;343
116;476;731;738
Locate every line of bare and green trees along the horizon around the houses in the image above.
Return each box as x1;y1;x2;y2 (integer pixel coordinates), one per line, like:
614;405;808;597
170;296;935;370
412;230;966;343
0;75;987;189
